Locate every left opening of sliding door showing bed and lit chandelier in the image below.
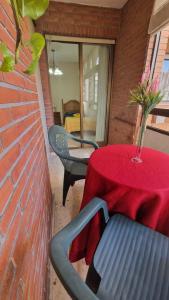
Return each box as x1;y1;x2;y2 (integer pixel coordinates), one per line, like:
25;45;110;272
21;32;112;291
48;42;80;147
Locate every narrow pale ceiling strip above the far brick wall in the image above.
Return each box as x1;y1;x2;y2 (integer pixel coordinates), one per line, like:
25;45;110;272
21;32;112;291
54;0;128;8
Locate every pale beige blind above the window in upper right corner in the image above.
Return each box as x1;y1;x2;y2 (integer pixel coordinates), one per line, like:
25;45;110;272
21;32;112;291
148;0;169;34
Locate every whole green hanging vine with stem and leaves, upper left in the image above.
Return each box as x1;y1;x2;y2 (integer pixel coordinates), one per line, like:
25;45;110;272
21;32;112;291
0;0;49;75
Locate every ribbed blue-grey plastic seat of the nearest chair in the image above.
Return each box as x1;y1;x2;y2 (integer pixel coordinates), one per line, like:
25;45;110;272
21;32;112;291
94;214;169;300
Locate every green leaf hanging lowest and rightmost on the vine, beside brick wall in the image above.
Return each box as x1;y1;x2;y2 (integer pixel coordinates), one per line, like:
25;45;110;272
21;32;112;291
25;32;45;75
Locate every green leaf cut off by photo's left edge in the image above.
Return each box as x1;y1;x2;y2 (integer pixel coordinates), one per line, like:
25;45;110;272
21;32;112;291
0;43;15;72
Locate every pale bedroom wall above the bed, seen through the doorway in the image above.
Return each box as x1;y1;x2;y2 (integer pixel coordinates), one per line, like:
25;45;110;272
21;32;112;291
50;63;80;112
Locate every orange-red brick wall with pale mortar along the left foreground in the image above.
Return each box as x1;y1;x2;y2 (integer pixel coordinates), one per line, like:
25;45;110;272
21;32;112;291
0;0;51;300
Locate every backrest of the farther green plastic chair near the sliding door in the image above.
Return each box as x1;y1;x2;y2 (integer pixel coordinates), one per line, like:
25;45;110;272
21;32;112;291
48;125;70;167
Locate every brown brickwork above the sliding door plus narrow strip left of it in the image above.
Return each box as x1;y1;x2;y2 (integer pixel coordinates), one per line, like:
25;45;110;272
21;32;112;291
36;1;121;127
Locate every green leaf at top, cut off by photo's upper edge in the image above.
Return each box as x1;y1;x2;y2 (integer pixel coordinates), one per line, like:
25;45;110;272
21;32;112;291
17;0;49;20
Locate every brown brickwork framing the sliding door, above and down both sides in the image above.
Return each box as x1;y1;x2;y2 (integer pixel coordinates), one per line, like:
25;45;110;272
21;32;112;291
37;0;154;144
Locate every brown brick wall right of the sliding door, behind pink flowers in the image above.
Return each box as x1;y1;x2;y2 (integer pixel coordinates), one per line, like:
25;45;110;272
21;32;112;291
109;0;154;143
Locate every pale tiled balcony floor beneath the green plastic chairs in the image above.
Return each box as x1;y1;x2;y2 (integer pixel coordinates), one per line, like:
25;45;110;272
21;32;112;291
49;148;92;300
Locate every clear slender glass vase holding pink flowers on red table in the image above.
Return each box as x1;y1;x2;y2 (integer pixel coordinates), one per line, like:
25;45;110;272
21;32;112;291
131;112;148;163
